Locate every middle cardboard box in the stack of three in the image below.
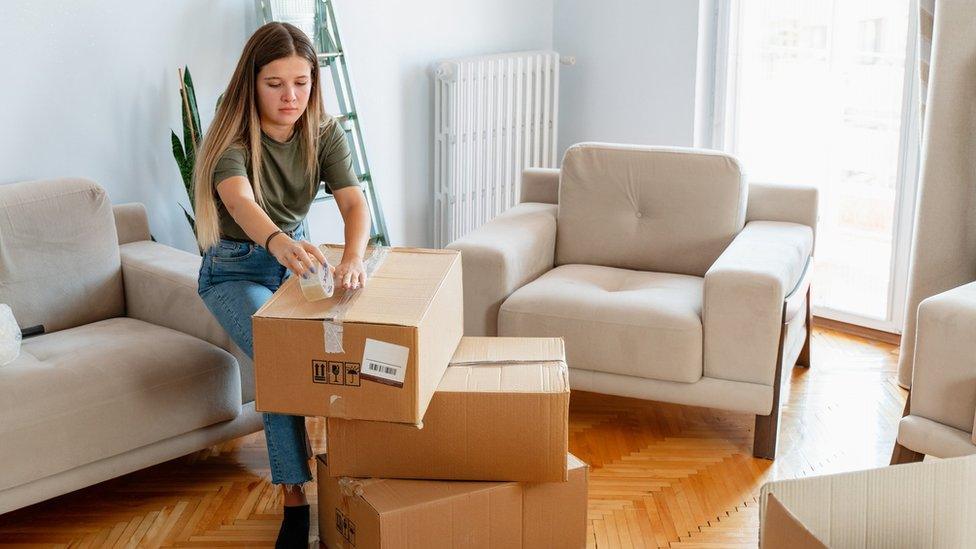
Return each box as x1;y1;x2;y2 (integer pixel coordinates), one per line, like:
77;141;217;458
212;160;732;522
327;337;569;482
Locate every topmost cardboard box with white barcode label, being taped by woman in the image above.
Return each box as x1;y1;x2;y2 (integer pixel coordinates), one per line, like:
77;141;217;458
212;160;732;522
252;245;464;424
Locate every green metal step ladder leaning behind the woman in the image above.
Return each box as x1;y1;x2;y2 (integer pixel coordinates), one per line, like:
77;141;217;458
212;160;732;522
256;0;390;246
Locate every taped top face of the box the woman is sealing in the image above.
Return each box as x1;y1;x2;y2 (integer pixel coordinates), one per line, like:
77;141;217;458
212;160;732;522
254;244;460;326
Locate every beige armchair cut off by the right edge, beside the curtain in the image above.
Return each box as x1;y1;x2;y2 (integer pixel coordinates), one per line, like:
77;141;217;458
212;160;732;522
891;281;976;463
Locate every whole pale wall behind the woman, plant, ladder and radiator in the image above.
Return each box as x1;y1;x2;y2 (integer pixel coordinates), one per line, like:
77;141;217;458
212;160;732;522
0;0;553;250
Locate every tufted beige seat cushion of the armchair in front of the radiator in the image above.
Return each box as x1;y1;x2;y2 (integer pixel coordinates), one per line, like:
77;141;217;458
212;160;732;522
498;265;703;383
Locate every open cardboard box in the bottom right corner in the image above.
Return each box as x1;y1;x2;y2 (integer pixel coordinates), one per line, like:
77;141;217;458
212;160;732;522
759;456;976;549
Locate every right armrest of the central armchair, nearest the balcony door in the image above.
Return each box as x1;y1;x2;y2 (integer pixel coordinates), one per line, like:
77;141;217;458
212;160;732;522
702;221;813;385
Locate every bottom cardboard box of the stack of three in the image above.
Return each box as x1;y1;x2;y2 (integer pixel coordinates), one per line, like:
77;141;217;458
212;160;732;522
316;454;587;549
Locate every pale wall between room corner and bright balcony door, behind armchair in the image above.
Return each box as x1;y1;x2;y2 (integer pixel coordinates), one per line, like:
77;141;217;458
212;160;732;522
553;0;699;157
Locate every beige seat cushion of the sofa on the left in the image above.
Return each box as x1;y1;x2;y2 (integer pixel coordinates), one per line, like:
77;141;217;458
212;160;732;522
0;318;241;490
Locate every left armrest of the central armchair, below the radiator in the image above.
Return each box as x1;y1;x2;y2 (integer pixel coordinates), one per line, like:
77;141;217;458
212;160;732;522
447;203;556;336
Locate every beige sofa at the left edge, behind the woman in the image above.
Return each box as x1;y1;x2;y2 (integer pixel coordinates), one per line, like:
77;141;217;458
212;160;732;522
0;179;262;513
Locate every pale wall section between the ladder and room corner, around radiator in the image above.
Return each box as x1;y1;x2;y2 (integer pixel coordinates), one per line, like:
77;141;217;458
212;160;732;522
322;0;553;246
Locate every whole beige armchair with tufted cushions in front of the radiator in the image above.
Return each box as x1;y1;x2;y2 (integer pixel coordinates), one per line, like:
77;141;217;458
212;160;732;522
449;143;817;459
